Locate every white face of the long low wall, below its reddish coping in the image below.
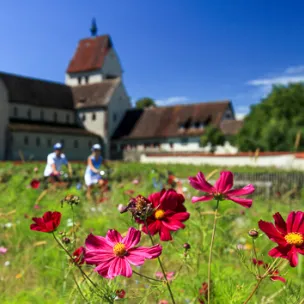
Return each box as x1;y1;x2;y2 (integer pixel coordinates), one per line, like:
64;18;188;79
140;154;304;170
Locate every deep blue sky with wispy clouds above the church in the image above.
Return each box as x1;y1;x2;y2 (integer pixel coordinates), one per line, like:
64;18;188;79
0;0;304;118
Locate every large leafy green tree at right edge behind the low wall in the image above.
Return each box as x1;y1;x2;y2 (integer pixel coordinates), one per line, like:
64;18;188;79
236;83;304;151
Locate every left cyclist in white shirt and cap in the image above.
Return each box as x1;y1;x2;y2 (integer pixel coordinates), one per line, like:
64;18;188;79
44;143;71;182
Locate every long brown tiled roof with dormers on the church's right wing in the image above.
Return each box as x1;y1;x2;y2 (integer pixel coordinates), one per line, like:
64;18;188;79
112;101;232;139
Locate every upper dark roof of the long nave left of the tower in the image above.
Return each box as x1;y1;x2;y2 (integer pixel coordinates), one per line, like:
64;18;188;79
0;72;74;110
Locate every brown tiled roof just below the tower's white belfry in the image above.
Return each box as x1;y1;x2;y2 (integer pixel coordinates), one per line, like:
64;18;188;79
72;78;121;109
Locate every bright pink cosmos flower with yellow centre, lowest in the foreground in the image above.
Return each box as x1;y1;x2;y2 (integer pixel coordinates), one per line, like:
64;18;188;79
85;227;162;279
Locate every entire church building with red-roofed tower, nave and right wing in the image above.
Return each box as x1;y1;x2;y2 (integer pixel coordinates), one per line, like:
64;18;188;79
0;24;240;160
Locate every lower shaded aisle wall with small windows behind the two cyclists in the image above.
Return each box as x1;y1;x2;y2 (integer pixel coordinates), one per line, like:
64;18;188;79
9;132;98;160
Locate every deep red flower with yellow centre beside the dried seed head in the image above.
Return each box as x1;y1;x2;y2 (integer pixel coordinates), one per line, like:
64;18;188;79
142;189;190;241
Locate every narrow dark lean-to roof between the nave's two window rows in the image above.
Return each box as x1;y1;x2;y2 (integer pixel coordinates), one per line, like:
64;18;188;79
8;120;98;137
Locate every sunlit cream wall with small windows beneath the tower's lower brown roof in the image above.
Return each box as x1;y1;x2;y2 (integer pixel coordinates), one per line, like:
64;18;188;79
77;109;106;138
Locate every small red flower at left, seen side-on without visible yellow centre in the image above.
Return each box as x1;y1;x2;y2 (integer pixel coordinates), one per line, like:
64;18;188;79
30;211;61;232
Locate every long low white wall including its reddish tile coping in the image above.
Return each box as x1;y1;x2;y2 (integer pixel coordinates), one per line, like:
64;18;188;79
140;152;304;170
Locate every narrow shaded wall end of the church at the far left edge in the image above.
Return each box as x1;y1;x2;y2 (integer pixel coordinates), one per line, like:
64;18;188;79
0;79;9;160
